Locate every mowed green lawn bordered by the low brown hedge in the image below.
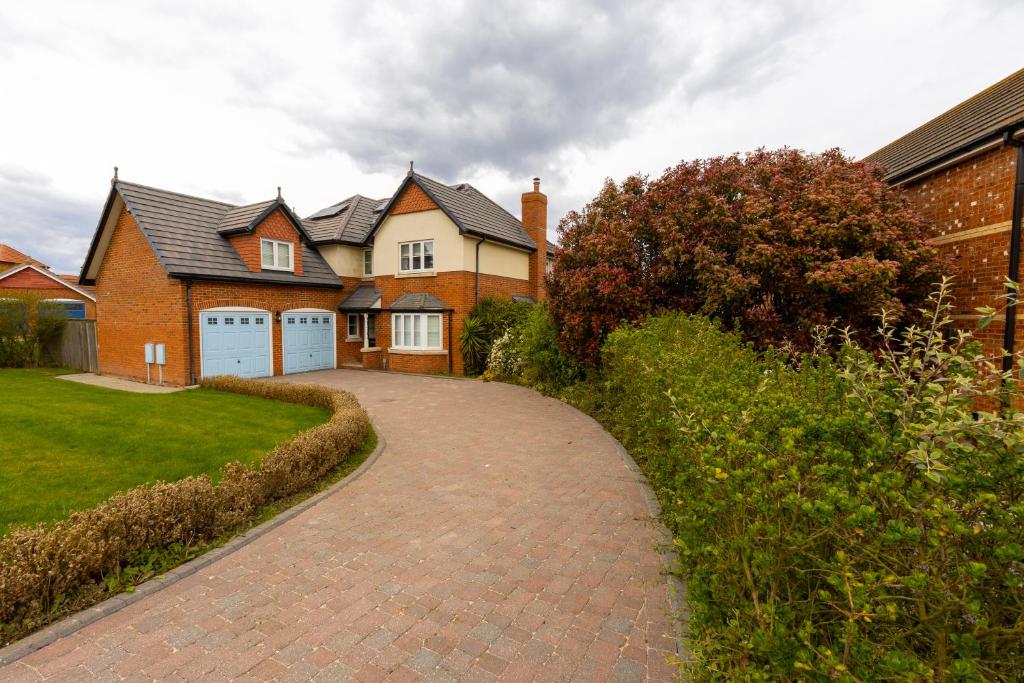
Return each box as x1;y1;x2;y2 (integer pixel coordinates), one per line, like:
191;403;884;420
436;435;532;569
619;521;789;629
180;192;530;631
0;370;329;535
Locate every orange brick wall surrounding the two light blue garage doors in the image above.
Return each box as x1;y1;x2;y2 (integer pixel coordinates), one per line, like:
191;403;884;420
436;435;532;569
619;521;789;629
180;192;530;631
191;281;347;377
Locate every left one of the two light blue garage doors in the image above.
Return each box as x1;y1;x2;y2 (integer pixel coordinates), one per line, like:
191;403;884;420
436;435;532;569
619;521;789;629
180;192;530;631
200;311;270;377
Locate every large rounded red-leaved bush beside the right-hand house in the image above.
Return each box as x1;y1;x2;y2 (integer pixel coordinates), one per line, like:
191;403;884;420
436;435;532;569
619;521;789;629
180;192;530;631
547;148;947;364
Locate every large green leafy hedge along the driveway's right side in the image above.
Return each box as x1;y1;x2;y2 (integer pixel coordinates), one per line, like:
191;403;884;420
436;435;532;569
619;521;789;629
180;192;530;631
565;288;1024;681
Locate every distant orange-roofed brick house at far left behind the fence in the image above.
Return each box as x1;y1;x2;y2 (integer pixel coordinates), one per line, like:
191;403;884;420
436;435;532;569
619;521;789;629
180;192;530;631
0;244;96;319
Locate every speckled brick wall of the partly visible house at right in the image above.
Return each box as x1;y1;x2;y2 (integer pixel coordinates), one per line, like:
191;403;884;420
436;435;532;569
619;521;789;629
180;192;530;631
904;145;1024;362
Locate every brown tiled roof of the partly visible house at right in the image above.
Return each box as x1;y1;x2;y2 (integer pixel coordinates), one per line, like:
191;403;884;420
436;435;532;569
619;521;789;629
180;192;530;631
864;69;1024;182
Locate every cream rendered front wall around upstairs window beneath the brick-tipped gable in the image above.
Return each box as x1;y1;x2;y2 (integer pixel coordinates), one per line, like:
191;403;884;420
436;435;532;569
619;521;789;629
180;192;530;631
374;209;466;275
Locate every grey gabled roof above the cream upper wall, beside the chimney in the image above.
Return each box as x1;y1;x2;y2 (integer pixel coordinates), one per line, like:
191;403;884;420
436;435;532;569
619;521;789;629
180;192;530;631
373;173;538;251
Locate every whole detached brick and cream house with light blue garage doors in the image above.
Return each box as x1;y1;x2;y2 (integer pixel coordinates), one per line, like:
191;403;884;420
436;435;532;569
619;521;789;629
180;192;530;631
80;171;553;384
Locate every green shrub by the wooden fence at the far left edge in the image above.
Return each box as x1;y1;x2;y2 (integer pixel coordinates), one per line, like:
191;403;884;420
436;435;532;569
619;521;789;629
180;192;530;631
0;296;68;368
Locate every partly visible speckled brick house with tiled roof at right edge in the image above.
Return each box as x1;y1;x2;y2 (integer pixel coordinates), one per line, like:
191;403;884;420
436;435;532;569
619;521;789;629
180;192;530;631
865;70;1024;369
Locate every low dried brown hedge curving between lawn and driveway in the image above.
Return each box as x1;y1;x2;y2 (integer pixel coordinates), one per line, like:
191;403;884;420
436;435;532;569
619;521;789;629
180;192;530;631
0;377;370;624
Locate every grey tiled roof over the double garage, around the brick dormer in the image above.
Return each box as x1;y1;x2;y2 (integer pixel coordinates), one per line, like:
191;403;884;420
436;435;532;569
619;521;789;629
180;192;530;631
94;181;341;287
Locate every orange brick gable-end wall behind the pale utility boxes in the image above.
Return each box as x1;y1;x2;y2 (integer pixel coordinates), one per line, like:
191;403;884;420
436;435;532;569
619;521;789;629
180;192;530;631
96;205;188;385
